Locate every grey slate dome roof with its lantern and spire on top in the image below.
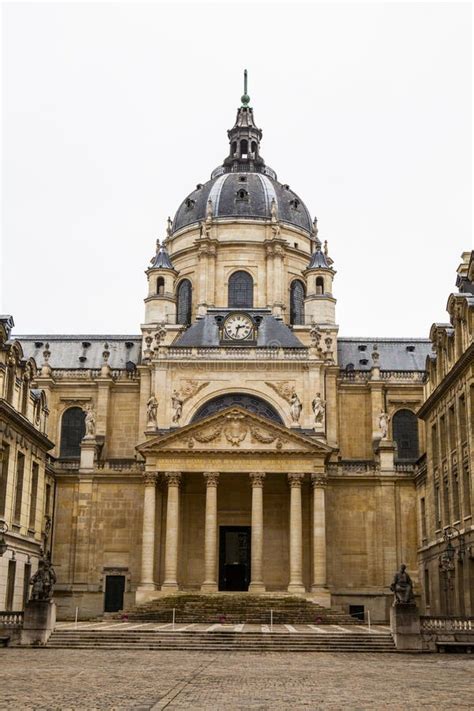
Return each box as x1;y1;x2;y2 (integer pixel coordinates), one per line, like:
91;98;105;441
172;76;313;234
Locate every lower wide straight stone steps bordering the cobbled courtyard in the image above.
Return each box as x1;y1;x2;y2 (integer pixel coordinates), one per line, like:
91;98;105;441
47;628;396;653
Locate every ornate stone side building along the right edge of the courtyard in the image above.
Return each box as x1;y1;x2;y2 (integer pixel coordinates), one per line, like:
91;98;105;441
416;252;474;617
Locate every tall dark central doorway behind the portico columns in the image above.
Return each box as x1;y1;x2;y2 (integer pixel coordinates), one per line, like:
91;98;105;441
219;526;250;591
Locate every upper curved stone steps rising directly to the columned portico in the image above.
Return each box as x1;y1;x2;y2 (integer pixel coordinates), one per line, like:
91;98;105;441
115;593;360;625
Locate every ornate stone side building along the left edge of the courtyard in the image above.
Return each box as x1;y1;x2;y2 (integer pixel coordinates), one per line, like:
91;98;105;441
0;316;55;610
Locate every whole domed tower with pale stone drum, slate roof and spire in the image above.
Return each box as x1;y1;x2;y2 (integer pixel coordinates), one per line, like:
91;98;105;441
145;74;335;346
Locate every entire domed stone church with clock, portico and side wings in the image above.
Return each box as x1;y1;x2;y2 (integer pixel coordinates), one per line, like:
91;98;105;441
1;89;470;620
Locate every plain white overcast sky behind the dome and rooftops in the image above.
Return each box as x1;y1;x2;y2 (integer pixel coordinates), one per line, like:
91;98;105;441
2;2;472;337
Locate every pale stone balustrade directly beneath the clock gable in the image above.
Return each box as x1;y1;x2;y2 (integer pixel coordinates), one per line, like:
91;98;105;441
162;346;309;360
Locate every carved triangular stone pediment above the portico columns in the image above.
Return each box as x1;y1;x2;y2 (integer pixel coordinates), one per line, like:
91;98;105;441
137;407;332;457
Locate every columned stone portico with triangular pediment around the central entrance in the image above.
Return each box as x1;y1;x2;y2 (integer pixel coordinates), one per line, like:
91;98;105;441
137;408;331;604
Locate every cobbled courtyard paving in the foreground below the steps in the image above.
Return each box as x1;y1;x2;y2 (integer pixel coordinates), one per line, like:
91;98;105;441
0;649;474;711
